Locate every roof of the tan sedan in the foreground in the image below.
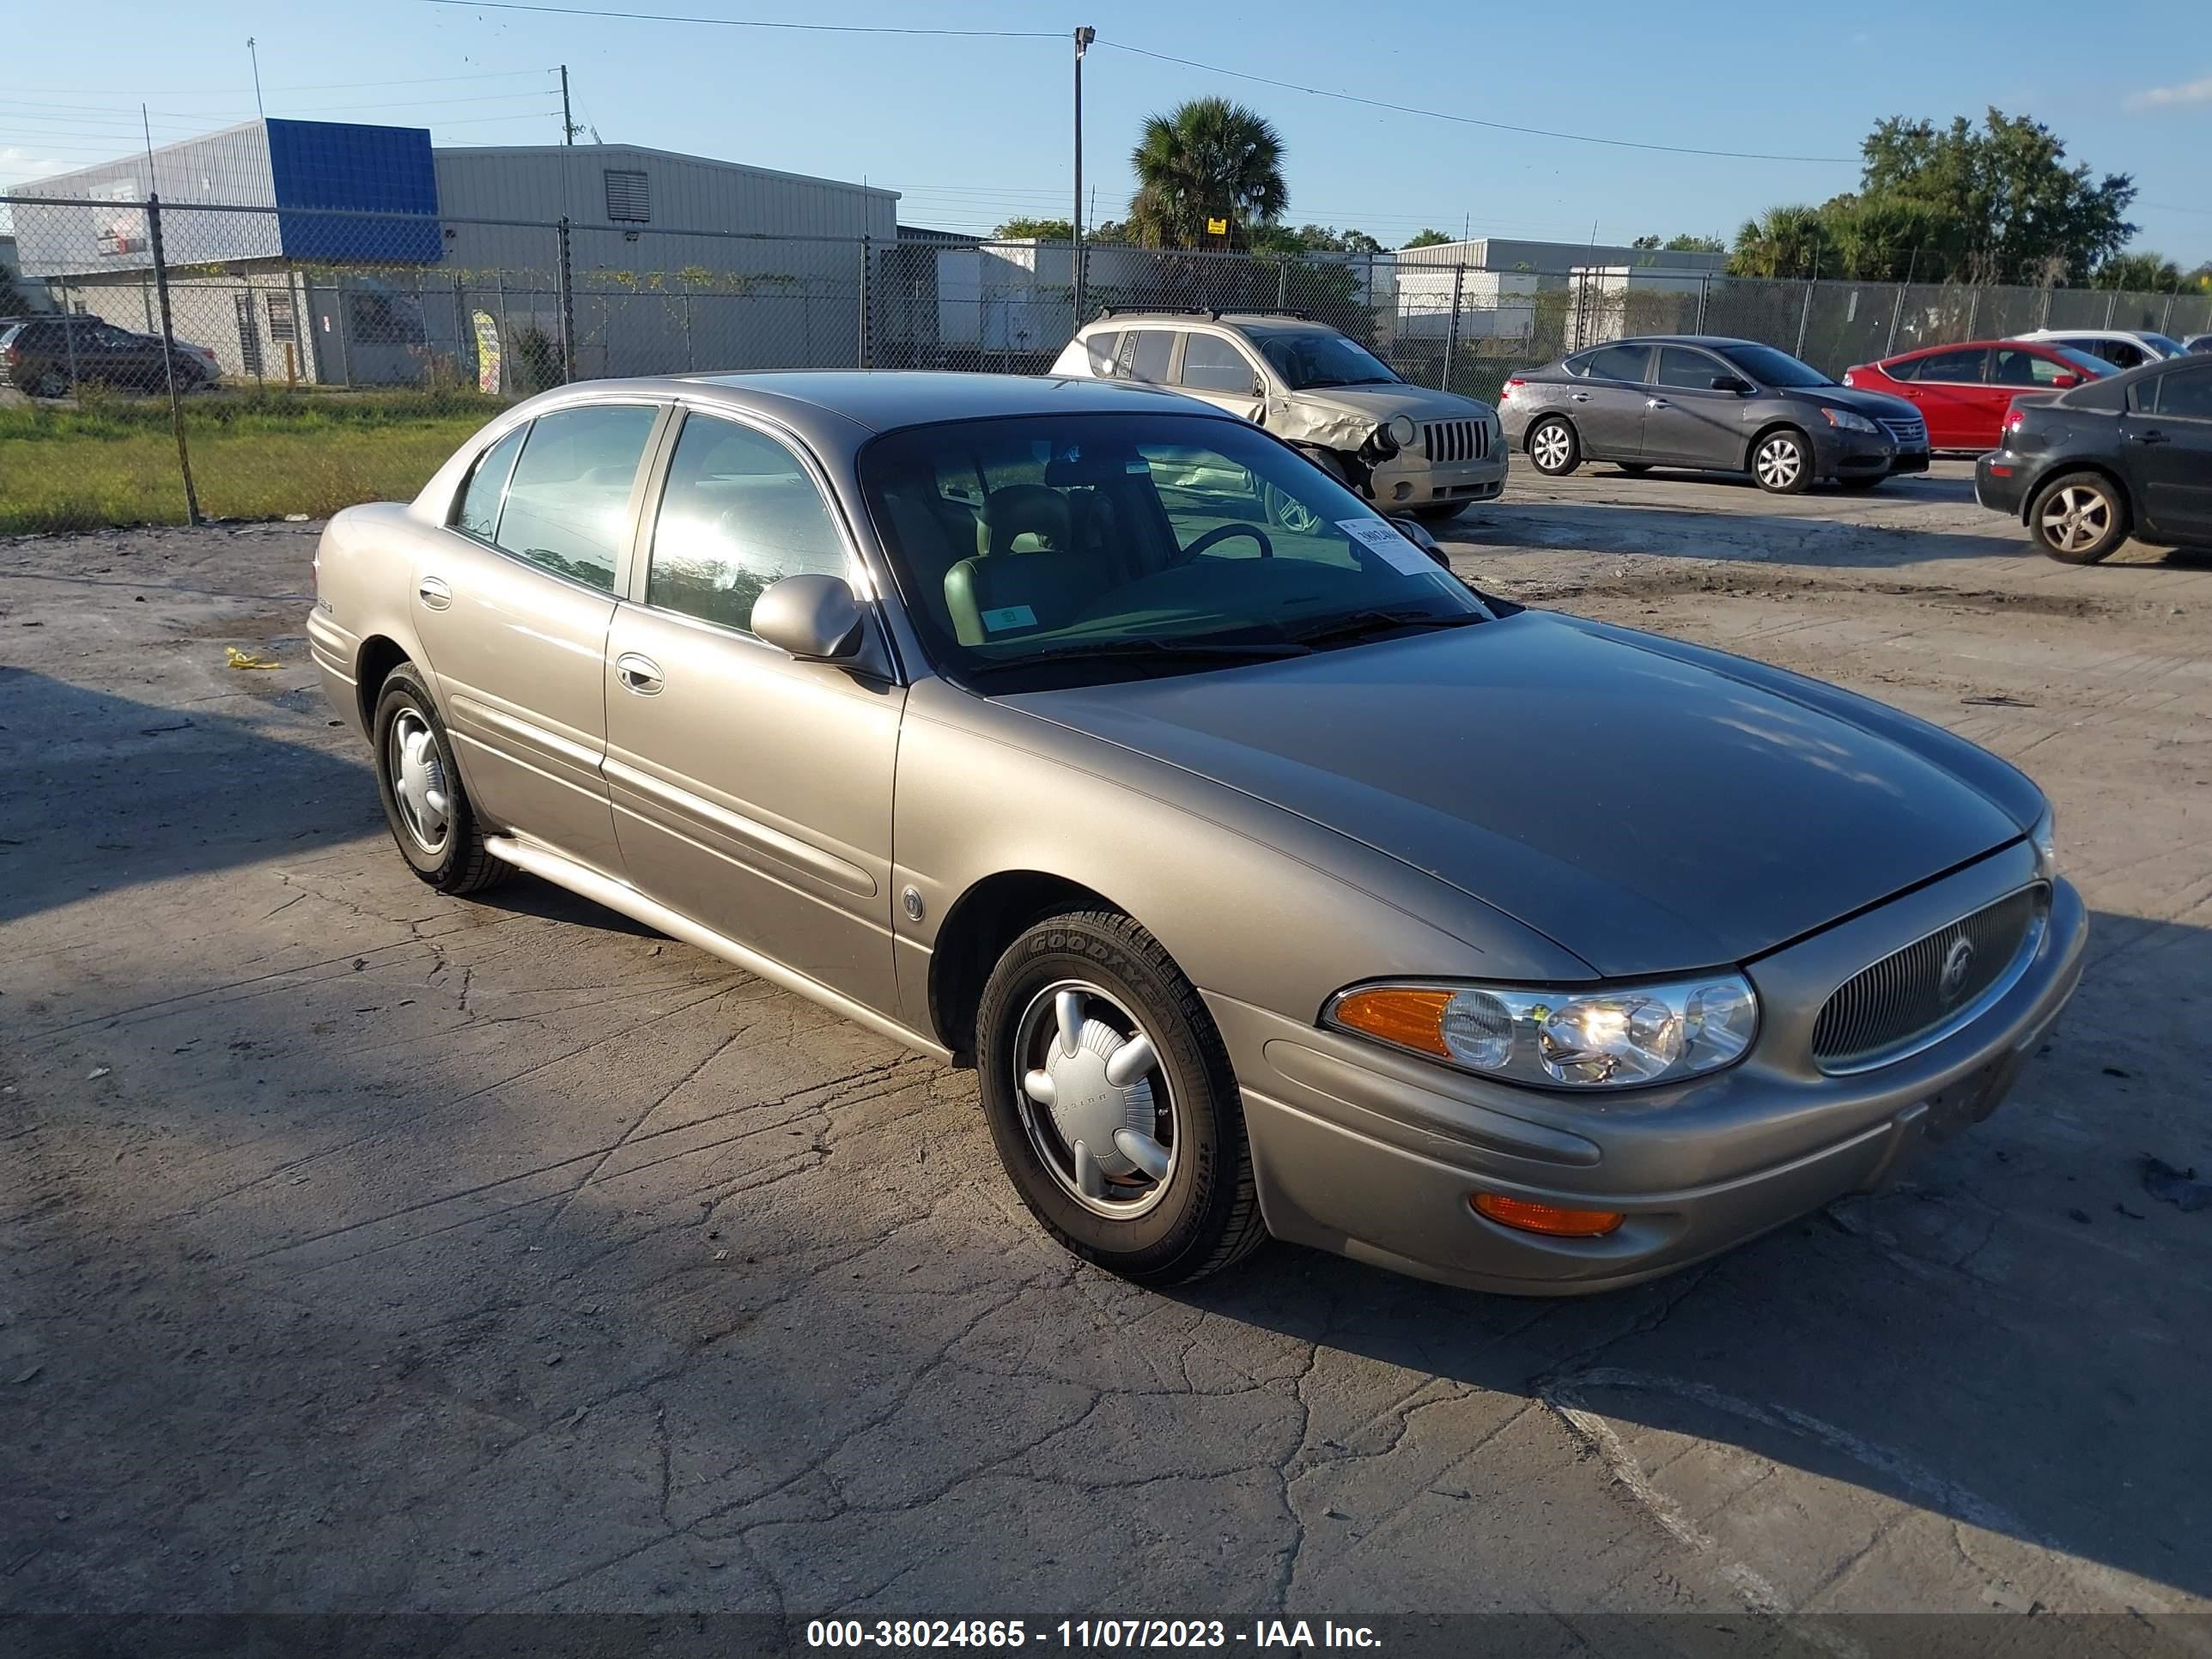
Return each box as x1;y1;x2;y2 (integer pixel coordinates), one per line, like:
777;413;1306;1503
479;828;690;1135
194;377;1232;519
677;369;1234;431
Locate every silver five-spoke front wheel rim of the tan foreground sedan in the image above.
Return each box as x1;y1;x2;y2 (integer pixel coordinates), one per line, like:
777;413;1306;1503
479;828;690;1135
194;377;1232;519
1013;980;1182;1221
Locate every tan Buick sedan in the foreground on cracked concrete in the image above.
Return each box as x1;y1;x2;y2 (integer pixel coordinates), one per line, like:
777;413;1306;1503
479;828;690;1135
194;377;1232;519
307;374;2086;1294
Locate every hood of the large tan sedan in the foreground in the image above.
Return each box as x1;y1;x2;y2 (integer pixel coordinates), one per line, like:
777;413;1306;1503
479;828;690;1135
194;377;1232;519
1005;611;2021;975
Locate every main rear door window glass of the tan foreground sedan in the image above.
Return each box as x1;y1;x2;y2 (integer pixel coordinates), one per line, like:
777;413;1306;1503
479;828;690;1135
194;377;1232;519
493;403;659;592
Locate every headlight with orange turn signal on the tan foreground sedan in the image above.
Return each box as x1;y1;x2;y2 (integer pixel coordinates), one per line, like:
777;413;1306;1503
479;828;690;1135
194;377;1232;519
1321;973;1759;1088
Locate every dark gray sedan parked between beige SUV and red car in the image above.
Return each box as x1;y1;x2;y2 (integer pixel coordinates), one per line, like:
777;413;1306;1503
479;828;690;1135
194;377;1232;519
1498;334;1929;495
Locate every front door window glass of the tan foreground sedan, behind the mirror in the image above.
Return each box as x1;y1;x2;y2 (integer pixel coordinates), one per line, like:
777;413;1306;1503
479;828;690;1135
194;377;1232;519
646;414;845;633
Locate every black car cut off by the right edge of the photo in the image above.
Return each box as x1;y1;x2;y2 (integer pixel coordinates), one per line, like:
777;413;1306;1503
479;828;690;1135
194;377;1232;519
1973;352;2212;564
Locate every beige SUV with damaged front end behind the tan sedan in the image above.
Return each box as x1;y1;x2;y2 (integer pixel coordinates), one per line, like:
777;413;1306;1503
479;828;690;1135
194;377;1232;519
1053;312;1506;525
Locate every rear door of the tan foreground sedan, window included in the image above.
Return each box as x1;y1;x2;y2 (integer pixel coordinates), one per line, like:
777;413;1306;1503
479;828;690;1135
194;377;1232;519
411;400;668;874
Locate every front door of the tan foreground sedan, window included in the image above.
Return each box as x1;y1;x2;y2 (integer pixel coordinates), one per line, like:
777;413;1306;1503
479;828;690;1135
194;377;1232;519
604;410;905;1018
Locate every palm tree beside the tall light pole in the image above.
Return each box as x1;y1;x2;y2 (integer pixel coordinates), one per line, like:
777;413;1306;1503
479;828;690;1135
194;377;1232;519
1128;97;1290;248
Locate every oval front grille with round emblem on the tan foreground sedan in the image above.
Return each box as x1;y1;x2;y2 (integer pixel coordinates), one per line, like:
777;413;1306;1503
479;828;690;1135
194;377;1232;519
1812;887;2044;1071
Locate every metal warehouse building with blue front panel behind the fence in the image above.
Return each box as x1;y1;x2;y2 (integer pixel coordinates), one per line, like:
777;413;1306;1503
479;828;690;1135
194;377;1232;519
15;119;898;389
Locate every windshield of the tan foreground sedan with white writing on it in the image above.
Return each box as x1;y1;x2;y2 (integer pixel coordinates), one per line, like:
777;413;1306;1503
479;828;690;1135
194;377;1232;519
858;411;1491;692
